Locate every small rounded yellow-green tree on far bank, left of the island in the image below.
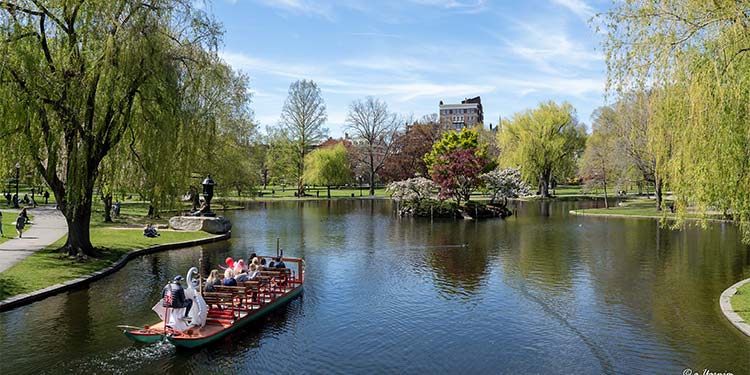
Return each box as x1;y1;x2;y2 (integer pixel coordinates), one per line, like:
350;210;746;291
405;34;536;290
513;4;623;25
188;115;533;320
304;143;353;187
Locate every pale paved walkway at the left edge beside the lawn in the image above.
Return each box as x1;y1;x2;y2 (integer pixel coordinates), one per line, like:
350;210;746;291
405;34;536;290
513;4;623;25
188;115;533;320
0;206;68;272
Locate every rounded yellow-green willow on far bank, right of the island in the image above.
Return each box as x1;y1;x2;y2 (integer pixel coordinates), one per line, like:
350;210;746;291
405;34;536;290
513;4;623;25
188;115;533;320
497;101;586;197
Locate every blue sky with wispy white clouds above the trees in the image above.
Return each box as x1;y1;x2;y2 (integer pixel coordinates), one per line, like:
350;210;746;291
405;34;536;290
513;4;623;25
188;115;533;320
210;0;608;137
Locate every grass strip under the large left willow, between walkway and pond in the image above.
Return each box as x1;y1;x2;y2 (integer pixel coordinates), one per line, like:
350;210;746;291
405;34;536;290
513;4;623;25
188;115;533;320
0;223;212;300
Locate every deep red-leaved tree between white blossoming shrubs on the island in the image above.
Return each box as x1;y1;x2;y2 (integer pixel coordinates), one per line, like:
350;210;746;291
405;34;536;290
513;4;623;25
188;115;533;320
432;148;487;206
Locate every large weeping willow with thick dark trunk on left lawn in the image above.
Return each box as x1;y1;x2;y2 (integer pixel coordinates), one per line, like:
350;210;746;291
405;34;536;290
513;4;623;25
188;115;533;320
0;0;219;255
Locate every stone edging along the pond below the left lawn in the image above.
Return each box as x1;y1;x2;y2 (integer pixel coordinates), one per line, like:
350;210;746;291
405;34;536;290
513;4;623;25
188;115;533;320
0;231;232;312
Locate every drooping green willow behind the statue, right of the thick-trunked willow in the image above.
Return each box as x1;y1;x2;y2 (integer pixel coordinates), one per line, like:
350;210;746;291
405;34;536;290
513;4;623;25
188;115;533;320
114;56;257;216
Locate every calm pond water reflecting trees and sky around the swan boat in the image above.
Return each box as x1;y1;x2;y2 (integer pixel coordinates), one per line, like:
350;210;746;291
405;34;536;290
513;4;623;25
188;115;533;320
0;200;750;374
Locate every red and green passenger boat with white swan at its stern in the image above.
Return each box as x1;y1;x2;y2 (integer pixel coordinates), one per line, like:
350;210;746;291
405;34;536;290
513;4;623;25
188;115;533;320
118;257;304;348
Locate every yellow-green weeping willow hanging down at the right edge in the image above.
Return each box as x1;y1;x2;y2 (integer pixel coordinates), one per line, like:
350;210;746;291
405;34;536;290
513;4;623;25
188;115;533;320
604;0;750;240
